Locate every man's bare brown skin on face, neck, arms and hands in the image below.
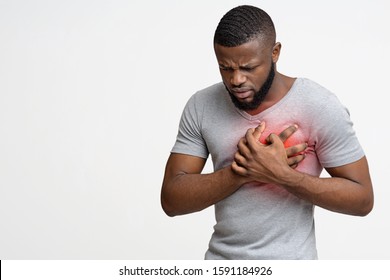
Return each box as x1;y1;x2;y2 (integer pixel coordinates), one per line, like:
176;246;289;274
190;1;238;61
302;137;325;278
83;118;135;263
161;38;373;216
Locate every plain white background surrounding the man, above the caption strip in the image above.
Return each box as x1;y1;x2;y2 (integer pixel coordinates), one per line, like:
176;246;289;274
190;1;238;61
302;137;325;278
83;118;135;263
0;0;390;259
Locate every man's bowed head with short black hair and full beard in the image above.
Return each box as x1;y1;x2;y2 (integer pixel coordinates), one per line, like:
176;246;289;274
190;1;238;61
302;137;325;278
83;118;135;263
214;6;281;111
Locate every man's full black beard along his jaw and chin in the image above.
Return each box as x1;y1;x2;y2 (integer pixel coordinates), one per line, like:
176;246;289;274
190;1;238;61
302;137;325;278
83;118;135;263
225;63;275;111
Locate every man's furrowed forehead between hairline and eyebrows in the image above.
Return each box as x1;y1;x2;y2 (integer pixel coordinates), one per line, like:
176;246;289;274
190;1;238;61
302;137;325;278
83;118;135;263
214;40;272;65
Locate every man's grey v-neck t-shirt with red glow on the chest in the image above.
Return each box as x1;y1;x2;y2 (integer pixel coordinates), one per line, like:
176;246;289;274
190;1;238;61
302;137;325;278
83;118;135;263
172;78;364;259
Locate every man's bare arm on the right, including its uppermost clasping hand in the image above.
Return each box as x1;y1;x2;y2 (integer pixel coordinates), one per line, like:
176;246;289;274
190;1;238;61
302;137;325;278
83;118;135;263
232;128;374;216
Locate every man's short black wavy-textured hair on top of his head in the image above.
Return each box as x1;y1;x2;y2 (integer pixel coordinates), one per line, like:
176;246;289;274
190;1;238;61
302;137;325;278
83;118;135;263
214;5;276;47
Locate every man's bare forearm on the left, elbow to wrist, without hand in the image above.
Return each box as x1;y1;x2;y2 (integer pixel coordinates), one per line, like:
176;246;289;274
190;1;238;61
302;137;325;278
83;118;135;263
161;166;243;216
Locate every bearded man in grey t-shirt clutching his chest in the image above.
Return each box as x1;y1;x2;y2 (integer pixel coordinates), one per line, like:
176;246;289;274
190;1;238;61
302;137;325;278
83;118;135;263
161;6;373;259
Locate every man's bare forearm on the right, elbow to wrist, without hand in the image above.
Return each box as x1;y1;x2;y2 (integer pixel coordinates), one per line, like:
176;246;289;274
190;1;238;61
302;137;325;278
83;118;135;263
282;170;373;216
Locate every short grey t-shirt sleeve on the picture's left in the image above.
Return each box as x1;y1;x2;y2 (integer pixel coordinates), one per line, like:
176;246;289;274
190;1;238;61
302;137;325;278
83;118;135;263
171;94;209;158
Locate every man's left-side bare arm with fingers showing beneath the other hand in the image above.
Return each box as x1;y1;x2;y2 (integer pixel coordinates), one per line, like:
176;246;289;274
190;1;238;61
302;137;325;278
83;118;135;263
161;124;306;216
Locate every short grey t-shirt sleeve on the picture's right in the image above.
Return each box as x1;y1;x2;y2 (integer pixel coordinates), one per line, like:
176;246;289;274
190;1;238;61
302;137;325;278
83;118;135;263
312;96;364;167
